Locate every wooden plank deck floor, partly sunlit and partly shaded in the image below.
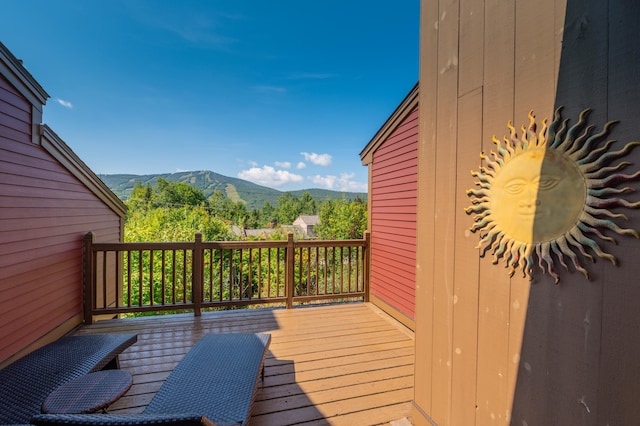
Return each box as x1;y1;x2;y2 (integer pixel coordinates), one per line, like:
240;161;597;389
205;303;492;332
77;303;414;426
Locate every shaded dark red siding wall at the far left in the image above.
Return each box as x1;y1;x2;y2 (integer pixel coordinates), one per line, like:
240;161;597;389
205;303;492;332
0;75;121;362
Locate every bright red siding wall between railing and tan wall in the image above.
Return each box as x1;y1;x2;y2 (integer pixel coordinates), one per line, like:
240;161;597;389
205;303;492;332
370;107;418;320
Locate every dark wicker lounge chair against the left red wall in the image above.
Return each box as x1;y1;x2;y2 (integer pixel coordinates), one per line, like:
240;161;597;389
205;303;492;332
0;334;137;424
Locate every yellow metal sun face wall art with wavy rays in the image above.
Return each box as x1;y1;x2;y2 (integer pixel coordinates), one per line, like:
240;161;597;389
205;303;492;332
465;108;640;283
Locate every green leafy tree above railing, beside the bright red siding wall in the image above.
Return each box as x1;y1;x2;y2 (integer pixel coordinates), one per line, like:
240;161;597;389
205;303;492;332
314;198;367;240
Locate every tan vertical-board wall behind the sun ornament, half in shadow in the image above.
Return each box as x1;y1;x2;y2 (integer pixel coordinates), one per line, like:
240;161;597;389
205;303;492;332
413;0;640;426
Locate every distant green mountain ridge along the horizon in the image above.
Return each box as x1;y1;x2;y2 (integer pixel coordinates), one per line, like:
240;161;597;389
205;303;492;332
98;170;367;209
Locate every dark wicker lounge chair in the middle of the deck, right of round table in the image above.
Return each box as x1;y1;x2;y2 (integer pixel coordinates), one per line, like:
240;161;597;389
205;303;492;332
31;333;271;426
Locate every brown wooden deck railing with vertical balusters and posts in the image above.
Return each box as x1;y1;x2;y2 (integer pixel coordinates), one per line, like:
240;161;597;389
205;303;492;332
84;233;370;323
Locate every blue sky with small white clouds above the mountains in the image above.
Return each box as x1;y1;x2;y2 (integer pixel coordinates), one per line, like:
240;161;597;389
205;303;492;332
0;0;419;191
